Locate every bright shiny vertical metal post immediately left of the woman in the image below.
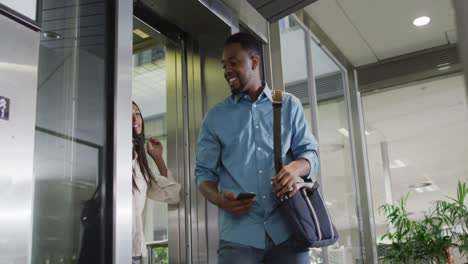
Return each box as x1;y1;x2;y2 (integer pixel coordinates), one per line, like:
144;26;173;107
113;0;133;264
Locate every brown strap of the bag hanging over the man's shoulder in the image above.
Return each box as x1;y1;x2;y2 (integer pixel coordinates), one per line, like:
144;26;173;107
272;90;283;174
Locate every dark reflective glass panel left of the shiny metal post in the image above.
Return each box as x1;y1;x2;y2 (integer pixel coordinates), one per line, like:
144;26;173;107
31;0;113;264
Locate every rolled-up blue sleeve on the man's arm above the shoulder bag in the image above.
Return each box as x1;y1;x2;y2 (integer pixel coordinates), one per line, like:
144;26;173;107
291;98;319;178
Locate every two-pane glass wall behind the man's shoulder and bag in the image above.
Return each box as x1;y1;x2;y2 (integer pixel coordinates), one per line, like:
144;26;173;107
280;18;362;263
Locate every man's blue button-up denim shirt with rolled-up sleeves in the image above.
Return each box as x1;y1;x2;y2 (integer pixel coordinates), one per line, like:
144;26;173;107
195;86;318;249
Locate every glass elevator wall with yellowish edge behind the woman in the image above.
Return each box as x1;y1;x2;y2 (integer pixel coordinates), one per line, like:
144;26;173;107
132;17;184;264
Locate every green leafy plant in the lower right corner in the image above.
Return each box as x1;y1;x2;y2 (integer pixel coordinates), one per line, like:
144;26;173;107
380;182;468;264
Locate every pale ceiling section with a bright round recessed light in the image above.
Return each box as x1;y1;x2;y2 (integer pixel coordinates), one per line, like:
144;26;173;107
304;0;457;66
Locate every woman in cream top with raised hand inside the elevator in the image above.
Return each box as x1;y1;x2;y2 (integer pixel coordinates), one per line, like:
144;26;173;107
132;102;180;264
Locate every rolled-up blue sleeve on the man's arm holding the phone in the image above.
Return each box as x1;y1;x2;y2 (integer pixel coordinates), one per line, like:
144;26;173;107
195;112;221;187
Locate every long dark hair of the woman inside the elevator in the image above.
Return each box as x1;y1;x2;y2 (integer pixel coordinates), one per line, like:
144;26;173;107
132;102;154;191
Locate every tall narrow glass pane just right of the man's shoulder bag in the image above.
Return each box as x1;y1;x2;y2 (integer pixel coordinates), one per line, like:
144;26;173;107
311;38;362;264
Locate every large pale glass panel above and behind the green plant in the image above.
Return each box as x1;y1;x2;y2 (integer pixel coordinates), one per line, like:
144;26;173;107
362;74;468;263
